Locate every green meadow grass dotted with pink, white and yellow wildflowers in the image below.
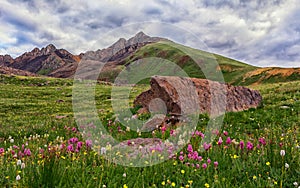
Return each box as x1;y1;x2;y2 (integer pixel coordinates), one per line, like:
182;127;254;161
0;75;300;188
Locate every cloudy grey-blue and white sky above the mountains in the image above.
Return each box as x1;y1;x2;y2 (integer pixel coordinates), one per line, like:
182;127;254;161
0;0;300;67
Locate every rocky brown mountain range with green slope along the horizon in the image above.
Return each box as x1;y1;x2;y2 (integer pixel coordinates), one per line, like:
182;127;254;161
0;32;300;85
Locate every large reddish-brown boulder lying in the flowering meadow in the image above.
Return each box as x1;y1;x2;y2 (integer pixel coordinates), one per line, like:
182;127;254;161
134;76;262;116
